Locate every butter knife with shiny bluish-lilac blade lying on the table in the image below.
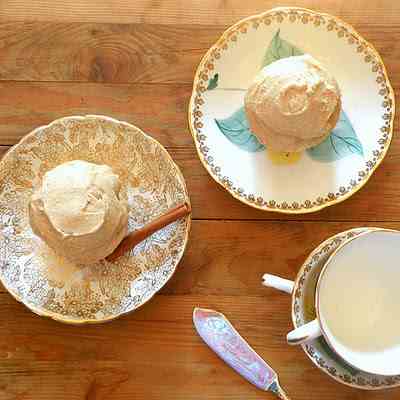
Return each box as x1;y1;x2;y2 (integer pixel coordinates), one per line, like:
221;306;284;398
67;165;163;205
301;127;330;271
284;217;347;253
193;308;290;400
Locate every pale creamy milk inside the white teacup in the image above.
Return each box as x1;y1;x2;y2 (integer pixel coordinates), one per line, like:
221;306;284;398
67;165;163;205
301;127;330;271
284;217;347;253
319;232;400;352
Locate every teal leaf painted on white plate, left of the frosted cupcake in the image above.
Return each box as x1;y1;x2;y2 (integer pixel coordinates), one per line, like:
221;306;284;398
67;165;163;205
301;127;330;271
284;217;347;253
215;107;265;152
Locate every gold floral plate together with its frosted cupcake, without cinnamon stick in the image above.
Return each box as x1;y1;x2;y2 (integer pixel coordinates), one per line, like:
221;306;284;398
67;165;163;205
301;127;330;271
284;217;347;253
0;115;191;324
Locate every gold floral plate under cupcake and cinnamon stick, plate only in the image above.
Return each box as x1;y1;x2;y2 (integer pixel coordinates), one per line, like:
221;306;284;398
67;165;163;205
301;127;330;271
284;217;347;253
0;116;191;324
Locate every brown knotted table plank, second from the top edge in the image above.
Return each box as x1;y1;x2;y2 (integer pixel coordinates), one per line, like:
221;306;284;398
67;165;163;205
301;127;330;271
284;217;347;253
0;22;400;83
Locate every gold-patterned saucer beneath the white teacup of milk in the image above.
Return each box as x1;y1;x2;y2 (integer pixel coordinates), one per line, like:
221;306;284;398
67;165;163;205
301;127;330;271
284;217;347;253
292;228;400;390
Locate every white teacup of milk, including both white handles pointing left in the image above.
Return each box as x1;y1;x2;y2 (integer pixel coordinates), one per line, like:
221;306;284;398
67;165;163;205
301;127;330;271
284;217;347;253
264;230;400;375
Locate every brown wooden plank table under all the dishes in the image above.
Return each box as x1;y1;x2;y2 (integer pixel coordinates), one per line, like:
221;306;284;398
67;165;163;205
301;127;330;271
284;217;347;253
0;0;400;400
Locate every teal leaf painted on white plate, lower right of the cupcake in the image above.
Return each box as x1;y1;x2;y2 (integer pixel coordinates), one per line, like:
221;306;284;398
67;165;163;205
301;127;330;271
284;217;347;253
307;110;364;162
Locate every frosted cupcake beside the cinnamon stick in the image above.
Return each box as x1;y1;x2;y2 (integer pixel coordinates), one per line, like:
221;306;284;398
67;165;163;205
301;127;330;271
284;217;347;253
29;160;128;264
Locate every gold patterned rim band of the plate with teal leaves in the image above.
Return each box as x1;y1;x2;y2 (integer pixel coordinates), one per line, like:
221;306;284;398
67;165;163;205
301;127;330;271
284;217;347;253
188;7;395;214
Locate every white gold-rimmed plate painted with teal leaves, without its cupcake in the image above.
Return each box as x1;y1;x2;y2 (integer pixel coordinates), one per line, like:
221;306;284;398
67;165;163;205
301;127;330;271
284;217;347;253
189;7;395;213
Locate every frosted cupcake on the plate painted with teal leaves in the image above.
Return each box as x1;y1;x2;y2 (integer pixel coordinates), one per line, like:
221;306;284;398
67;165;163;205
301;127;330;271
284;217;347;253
245;55;341;152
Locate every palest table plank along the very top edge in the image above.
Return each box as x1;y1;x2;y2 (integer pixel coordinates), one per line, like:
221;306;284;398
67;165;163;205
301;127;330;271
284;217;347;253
0;0;400;25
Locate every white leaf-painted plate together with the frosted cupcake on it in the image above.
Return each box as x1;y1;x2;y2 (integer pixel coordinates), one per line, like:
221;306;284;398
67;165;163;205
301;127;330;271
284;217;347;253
189;7;395;214
